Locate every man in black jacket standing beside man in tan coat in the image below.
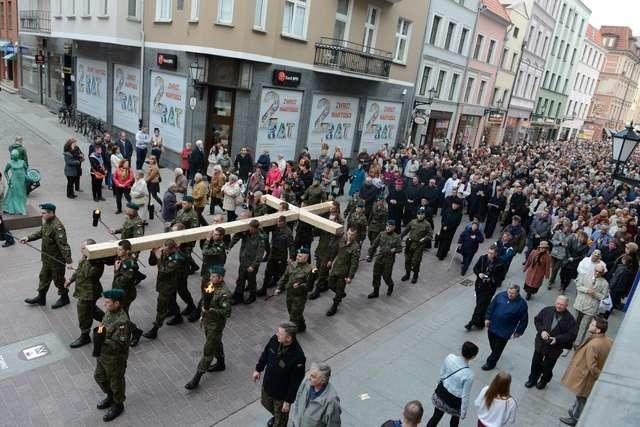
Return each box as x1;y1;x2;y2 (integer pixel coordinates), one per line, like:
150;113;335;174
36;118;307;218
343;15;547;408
524;295;578;390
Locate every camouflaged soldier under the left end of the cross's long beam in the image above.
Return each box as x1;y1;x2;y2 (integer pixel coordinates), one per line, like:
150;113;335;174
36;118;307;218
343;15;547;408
64;239;104;348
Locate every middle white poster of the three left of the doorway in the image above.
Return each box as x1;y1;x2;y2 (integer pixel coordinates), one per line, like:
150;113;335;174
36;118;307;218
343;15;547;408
113;64;140;133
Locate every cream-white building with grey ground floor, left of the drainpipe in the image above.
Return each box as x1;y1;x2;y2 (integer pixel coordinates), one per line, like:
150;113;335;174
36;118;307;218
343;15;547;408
20;0;143;133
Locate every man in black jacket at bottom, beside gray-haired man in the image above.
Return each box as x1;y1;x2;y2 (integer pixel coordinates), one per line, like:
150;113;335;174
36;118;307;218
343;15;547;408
253;323;307;427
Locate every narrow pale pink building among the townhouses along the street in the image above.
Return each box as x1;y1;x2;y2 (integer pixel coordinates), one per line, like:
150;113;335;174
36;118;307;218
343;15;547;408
454;0;511;147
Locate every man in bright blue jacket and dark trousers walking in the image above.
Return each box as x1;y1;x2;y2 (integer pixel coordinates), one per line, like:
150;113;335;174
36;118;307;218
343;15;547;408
482;285;529;371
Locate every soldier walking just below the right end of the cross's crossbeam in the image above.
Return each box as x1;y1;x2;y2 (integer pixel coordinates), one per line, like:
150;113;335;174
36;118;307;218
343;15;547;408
327;227;360;316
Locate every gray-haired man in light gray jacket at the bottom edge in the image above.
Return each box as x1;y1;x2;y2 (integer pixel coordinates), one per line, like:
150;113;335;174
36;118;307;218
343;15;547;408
287;362;341;427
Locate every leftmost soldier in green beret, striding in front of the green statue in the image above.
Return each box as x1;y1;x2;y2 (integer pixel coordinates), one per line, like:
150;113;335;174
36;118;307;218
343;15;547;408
20;203;73;308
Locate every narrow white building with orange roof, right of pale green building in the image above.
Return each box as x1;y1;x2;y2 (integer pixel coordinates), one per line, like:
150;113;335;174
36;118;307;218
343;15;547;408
559;25;606;141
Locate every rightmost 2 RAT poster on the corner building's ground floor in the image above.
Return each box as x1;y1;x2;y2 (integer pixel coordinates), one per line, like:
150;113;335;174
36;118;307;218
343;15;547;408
360;100;402;154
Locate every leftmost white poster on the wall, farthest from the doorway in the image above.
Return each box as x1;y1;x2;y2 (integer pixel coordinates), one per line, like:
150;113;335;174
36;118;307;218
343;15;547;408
76;57;107;121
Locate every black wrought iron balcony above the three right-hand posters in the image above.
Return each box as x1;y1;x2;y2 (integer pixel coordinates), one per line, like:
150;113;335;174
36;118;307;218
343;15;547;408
314;37;393;79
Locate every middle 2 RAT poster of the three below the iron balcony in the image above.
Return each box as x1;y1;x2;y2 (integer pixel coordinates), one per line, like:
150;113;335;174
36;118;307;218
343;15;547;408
307;95;359;159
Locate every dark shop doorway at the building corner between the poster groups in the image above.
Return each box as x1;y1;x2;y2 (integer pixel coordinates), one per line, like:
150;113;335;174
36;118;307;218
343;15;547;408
205;86;236;153
